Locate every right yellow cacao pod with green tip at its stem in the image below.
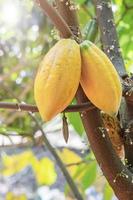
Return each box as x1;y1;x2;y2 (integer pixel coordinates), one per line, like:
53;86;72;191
80;41;122;116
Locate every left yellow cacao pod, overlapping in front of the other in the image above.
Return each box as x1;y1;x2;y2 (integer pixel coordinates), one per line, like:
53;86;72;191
34;39;81;121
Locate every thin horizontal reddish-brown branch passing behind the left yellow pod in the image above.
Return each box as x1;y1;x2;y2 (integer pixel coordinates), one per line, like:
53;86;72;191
0;102;95;113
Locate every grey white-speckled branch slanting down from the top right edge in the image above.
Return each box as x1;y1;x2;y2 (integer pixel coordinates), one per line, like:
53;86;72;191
93;0;127;77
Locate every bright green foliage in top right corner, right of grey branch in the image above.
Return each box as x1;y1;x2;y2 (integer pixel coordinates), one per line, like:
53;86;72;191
115;0;133;72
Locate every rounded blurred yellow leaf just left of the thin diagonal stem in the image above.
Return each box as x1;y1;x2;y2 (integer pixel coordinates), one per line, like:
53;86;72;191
34;158;57;185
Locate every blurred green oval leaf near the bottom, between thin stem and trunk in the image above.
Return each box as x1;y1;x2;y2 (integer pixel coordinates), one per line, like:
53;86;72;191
81;162;97;190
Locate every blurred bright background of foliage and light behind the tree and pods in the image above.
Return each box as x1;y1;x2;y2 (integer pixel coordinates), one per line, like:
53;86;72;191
0;0;133;200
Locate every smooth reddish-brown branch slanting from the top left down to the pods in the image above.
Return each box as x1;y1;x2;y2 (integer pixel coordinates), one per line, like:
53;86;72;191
36;0;73;38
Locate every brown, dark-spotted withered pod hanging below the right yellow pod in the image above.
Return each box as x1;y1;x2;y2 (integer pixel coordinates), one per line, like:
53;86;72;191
101;113;125;159
